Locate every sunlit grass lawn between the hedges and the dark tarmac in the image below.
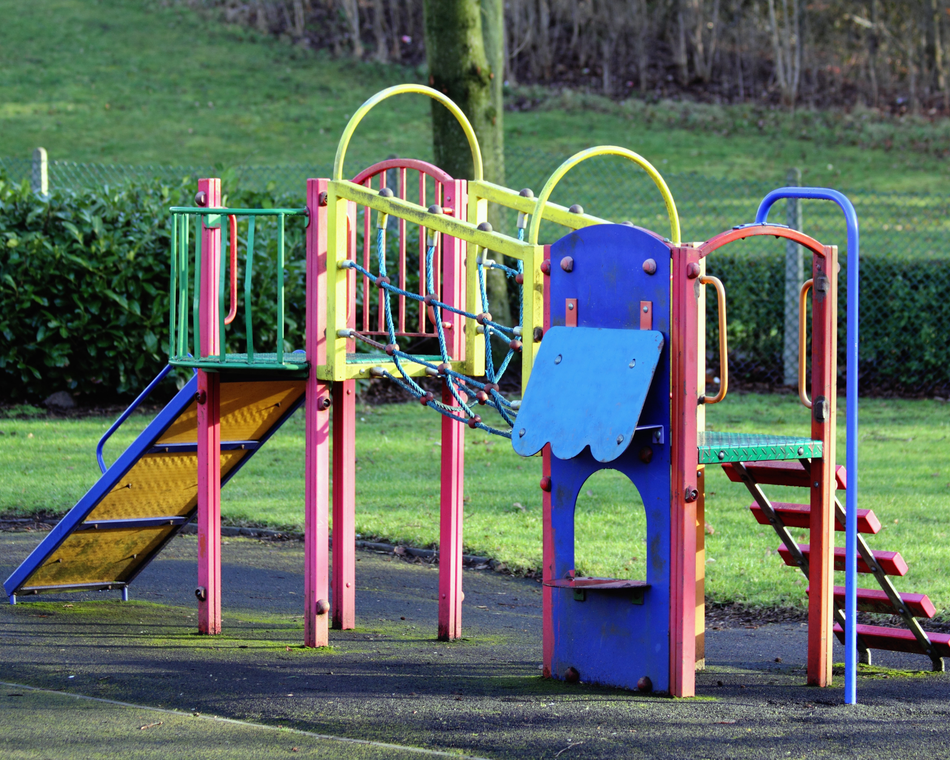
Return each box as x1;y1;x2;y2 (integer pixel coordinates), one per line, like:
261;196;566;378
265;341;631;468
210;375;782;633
0;394;950;618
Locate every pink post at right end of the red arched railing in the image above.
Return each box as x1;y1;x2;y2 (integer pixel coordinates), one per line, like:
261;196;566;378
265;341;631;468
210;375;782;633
438;180;467;641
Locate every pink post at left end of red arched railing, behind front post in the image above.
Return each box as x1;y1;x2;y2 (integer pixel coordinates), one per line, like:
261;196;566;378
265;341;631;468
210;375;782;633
330;203;357;630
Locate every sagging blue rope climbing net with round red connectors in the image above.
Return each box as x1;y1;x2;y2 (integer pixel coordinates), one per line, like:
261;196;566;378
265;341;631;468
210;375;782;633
341;189;528;438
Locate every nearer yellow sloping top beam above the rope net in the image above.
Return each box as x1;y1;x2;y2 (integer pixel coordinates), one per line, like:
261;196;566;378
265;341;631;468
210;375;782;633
331;180;541;261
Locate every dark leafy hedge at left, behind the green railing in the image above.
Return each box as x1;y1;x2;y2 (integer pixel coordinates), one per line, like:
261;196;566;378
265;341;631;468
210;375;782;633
0;177;305;402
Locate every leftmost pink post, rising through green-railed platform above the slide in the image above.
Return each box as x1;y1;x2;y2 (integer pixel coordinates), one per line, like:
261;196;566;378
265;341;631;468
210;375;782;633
196;179;221;634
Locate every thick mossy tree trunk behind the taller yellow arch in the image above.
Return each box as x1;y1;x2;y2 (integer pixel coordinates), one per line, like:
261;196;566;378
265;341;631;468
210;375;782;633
423;0;512;332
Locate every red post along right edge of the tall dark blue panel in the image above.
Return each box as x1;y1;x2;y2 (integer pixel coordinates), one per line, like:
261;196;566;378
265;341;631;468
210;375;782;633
670;247;701;697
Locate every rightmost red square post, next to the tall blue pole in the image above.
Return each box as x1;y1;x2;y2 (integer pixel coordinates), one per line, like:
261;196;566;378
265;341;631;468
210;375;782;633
808;246;840;686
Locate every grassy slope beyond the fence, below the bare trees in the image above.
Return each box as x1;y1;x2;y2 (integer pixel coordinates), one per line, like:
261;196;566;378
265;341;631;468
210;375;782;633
0;0;950;193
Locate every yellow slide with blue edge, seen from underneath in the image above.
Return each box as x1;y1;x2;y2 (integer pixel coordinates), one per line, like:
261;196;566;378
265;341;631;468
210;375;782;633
3;374;306;602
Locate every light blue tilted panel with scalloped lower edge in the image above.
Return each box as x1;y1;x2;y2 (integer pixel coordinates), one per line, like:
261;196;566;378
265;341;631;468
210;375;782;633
511;327;664;462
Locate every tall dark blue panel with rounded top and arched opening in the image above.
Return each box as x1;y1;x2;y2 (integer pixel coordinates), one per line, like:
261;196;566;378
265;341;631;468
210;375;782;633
536;225;671;692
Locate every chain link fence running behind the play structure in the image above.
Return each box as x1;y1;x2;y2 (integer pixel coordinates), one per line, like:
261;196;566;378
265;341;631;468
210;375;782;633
0;149;950;398
